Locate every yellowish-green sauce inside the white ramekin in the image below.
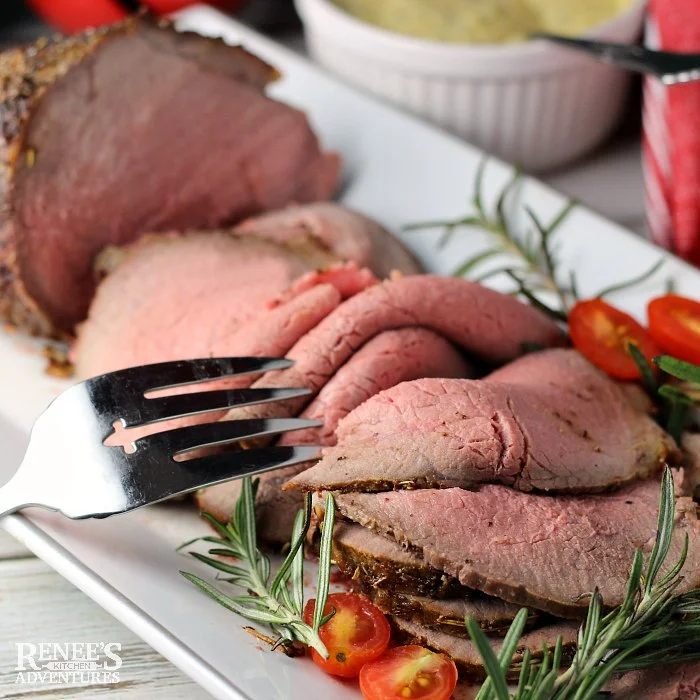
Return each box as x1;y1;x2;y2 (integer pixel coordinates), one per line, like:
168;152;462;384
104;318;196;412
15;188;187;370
333;0;635;43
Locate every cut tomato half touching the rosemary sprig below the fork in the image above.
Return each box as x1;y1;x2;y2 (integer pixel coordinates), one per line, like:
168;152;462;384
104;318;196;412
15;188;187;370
304;593;391;678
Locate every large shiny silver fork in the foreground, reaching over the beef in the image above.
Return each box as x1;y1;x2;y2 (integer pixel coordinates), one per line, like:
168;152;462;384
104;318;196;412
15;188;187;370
0;357;320;518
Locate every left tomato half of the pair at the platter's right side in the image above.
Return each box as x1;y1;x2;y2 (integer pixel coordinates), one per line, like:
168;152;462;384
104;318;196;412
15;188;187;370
569;299;659;379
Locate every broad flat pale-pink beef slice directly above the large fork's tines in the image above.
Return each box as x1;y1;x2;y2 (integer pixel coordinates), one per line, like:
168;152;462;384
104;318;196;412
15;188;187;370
74;231;318;378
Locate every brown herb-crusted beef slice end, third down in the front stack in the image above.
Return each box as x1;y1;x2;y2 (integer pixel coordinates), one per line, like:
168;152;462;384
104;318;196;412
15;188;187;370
333;522;472;599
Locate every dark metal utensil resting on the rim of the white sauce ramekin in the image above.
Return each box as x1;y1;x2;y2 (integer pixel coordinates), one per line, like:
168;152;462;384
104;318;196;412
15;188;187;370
532;33;700;85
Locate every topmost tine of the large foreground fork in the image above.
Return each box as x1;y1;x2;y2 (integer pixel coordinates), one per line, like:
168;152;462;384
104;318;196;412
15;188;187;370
86;357;294;400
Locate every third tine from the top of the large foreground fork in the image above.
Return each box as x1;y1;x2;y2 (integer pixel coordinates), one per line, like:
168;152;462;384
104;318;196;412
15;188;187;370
130;418;323;458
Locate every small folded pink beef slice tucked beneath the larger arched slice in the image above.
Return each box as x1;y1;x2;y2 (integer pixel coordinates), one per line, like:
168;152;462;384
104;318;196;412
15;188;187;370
197;328;470;544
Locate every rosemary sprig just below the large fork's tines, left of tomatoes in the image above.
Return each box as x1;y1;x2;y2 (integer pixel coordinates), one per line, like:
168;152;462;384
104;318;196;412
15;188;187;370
178;477;335;658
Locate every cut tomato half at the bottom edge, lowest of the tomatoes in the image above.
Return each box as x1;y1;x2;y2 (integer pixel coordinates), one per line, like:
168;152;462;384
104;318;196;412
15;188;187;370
360;645;457;700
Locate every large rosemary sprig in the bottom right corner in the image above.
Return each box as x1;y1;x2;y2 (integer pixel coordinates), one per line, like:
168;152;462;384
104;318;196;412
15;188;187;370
465;468;700;700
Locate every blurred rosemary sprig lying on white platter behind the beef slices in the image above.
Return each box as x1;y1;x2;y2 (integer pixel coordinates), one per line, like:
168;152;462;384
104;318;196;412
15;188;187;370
404;159;665;321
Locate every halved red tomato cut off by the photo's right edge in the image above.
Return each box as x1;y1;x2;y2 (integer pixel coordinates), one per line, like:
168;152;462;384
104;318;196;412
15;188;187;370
647;294;700;364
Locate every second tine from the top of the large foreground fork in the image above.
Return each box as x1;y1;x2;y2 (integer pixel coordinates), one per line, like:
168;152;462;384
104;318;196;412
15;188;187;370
115;388;311;428
